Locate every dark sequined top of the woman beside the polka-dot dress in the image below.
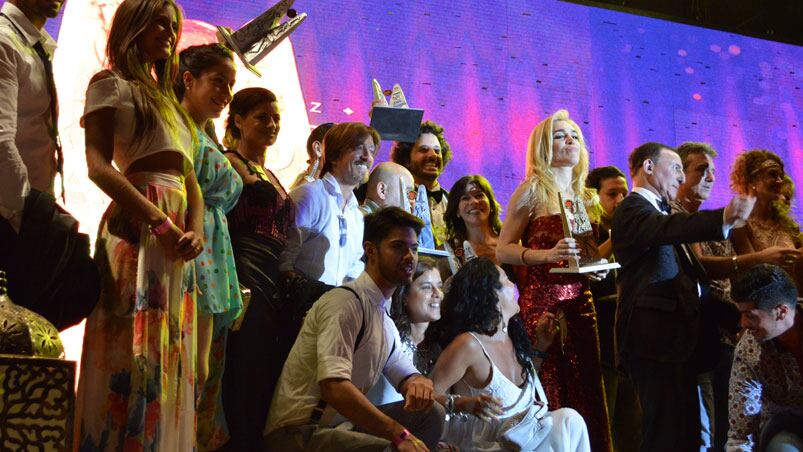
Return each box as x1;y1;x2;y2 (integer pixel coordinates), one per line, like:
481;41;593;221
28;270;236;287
226;150;295;245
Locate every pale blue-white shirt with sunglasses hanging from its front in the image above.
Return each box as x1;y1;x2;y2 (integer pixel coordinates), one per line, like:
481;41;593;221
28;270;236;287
279;173;365;286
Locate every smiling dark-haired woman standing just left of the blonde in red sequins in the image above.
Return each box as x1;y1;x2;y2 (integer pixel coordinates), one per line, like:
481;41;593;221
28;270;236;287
443;175;502;265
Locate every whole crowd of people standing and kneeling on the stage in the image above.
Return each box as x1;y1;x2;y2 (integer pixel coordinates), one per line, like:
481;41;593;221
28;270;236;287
0;0;803;452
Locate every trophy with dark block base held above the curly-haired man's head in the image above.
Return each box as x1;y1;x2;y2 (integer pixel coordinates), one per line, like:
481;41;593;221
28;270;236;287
371;79;424;143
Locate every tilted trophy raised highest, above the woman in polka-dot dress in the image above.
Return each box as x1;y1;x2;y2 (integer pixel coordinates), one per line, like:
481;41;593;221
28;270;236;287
217;0;307;77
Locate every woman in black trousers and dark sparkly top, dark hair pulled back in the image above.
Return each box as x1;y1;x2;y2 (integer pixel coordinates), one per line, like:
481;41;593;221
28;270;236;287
221;88;295;452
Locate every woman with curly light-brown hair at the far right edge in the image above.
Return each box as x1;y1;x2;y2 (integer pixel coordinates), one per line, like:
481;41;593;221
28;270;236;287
730;149;803;289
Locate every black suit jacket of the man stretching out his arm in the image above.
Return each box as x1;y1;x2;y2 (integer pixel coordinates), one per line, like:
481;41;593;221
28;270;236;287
611;193;723;365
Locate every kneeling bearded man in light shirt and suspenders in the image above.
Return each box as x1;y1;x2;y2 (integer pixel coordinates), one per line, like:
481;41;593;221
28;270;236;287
265;208;444;451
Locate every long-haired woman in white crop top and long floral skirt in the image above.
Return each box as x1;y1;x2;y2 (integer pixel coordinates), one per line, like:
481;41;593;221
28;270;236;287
75;0;204;451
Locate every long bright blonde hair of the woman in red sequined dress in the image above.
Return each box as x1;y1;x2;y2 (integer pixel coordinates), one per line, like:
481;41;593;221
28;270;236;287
519;110;599;220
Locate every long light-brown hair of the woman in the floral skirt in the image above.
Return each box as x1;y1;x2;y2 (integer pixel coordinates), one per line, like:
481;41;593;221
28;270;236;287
106;0;197;143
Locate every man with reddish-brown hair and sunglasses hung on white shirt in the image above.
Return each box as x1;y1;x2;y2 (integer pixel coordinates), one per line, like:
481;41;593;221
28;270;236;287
279;122;380;286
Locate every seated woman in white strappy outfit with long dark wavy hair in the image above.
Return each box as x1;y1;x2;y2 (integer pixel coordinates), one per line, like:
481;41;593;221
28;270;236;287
432;257;590;451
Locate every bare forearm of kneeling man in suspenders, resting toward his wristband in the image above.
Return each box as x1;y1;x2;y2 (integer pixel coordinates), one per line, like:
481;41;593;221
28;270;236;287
321;380;405;441
